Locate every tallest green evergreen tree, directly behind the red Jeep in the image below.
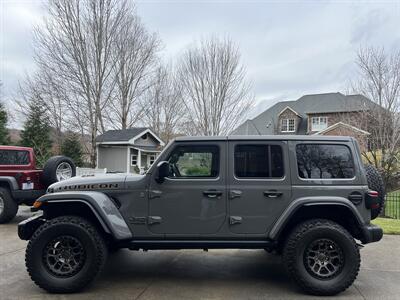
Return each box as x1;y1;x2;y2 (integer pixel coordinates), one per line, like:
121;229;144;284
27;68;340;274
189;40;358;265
21;99;52;167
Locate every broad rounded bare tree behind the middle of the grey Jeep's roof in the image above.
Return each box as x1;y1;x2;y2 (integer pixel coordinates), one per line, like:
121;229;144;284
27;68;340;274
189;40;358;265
178;37;252;135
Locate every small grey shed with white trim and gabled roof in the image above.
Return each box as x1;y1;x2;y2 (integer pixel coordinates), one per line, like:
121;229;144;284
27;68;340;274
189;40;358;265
96;127;165;173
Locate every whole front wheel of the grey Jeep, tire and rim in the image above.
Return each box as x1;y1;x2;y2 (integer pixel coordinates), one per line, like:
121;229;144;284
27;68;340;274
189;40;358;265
25;216;107;293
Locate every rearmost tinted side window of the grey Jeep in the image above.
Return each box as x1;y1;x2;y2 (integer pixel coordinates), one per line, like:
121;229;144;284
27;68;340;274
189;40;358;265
296;144;355;179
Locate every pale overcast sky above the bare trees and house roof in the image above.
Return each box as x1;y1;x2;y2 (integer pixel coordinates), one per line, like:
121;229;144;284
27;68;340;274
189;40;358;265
0;0;400;126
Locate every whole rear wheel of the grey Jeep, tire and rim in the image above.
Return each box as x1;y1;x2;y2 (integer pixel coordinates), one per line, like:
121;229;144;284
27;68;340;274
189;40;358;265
283;219;360;296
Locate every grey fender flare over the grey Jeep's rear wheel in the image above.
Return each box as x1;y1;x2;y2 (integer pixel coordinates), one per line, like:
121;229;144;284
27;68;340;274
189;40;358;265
268;196;364;240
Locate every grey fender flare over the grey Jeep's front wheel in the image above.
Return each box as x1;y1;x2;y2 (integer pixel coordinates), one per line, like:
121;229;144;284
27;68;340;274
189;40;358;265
37;191;132;240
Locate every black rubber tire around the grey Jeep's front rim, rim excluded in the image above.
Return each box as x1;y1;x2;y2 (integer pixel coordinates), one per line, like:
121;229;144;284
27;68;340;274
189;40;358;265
25;216;107;293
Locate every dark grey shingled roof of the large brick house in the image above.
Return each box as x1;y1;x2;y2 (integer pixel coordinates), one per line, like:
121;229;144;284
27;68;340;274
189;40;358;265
232;93;376;135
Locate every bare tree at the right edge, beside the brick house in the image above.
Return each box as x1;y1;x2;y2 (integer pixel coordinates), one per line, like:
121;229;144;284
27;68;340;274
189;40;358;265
352;47;400;188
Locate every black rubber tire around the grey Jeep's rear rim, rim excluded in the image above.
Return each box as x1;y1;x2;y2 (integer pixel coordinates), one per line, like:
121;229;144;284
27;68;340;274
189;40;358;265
283;219;360;296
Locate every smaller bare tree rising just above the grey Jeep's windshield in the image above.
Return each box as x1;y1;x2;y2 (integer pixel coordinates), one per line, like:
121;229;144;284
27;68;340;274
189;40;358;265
143;65;185;142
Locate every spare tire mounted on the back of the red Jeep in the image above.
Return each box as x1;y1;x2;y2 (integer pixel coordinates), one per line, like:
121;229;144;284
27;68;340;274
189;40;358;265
42;155;76;185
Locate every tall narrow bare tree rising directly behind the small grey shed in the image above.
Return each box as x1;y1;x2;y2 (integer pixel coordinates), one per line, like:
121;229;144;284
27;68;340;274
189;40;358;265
107;10;160;129
